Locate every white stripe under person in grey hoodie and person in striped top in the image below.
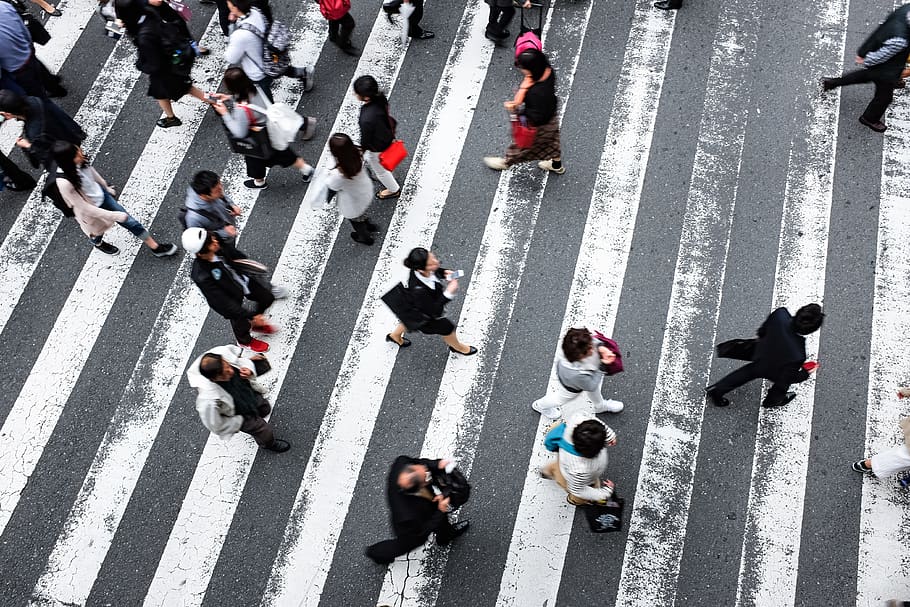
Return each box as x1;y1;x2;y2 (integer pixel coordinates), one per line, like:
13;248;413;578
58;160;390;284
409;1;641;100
496;0;673;607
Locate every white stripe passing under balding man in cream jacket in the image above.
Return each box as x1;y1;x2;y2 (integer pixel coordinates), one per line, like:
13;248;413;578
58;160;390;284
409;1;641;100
145;4;416;606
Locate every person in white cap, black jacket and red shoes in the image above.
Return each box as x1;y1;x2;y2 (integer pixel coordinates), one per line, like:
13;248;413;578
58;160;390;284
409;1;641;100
181;228;287;353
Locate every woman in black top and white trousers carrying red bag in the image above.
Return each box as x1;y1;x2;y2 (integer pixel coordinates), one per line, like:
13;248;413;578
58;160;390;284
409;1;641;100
354;76;401;200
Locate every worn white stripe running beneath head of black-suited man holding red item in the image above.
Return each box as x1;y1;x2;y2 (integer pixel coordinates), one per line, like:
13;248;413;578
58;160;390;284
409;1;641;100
736;0;849;607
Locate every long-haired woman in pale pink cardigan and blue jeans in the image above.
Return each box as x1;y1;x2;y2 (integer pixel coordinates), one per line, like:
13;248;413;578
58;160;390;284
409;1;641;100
53;141;177;257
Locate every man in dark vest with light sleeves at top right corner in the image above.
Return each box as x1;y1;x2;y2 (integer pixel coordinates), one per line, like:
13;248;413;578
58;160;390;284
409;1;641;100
822;4;910;133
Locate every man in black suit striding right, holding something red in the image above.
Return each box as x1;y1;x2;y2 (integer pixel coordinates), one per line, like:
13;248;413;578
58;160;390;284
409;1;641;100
705;303;825;407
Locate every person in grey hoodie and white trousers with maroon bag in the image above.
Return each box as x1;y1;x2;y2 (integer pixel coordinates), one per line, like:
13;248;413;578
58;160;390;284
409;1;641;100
531;328;623;419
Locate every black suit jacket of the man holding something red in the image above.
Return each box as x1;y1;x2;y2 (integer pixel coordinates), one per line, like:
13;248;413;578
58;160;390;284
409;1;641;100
752;308;809;384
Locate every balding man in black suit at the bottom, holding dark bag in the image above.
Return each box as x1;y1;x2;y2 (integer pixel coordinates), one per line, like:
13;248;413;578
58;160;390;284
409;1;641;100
366;455;470;564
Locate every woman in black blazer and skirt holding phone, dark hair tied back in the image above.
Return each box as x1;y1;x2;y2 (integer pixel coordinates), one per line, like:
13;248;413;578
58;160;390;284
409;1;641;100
385;247;477;356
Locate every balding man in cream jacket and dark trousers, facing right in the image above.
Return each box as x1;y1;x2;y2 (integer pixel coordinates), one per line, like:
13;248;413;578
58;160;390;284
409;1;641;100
186;345;291;453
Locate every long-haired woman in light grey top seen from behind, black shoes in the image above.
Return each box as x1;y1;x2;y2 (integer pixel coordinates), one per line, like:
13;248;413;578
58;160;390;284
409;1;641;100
326;133;379;246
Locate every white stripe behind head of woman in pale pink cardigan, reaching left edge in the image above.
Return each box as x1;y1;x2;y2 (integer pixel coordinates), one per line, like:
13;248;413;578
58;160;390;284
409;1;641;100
0;35;139;342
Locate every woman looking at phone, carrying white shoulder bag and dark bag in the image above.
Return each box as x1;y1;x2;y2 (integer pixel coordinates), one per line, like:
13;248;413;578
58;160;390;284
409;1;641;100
213;67;316;190
